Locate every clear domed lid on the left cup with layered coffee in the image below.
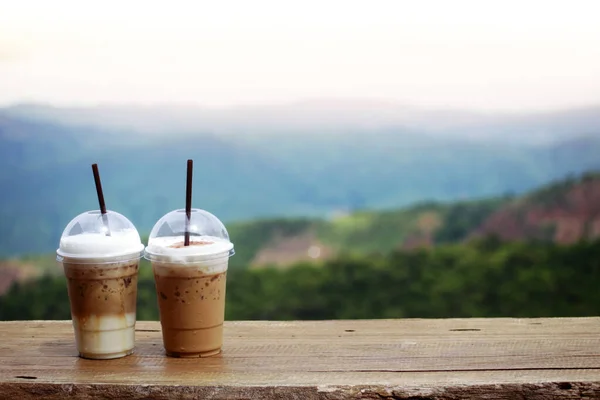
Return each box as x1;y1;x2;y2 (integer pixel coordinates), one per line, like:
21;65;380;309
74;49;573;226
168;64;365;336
56;210;144;261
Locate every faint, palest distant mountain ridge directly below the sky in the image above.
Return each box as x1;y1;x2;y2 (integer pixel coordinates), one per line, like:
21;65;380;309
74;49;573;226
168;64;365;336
3;99;600;145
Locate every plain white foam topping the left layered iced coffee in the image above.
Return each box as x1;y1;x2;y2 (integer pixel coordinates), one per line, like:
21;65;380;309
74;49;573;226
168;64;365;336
56;229;144;258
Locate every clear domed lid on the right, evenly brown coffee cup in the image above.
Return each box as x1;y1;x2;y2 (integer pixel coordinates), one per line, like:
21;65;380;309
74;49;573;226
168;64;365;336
145;208;235;264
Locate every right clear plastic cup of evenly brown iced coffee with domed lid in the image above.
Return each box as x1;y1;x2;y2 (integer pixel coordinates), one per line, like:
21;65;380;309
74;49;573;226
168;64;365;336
145;209;234;357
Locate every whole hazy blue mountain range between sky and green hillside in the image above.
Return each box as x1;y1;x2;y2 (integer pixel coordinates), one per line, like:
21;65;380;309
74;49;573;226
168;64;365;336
0;103;600;256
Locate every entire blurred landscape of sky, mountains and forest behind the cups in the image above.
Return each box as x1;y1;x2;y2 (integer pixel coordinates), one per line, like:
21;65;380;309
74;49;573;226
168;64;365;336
0;0;600;320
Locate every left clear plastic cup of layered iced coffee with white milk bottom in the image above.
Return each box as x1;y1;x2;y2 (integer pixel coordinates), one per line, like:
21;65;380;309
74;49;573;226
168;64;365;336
56;211;144;359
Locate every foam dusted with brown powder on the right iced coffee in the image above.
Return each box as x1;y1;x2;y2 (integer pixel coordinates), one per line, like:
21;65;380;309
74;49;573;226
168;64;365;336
146;235;233;264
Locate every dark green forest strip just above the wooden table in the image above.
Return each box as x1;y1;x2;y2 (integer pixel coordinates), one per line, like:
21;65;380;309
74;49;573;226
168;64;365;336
0;237;600;320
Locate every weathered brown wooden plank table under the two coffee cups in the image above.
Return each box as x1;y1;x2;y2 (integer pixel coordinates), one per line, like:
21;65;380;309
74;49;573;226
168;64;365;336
0;318;600;400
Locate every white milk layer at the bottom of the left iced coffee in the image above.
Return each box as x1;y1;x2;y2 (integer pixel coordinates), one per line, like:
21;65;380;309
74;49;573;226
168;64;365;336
73;313;135;359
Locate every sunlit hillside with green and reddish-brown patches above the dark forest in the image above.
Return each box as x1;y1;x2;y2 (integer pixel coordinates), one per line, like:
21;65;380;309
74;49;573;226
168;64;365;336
0;173;600;294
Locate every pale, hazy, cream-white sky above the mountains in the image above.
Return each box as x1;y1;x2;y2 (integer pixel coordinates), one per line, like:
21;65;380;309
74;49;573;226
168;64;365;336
0;0;600;110
